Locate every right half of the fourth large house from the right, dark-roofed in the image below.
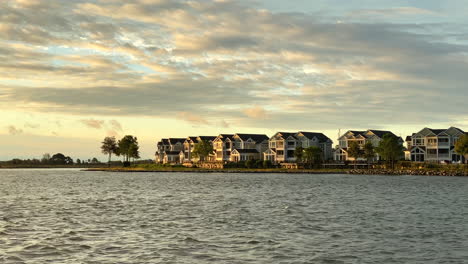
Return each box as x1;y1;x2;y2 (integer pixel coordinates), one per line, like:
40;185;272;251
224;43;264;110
230;133;269;162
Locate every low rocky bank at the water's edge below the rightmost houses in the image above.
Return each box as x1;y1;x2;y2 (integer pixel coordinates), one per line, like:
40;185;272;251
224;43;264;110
348;169;468;177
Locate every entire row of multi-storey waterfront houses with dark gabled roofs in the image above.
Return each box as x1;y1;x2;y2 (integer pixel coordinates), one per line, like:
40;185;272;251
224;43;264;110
156;127;466;164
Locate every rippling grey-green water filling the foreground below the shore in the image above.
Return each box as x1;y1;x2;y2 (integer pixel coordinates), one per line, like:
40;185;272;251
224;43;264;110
0;170;468;264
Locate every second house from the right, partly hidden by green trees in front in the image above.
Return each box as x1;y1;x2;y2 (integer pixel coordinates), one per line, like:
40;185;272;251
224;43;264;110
334;129;403;161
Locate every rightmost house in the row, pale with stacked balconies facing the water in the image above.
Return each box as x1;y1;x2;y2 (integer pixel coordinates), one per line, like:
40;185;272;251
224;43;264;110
408;127;465;162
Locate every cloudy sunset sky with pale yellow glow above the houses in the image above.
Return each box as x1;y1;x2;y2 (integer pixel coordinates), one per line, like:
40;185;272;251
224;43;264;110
0;0;468;160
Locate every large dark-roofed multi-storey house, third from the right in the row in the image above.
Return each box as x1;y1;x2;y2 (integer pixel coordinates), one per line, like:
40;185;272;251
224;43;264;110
263;131;333;163
